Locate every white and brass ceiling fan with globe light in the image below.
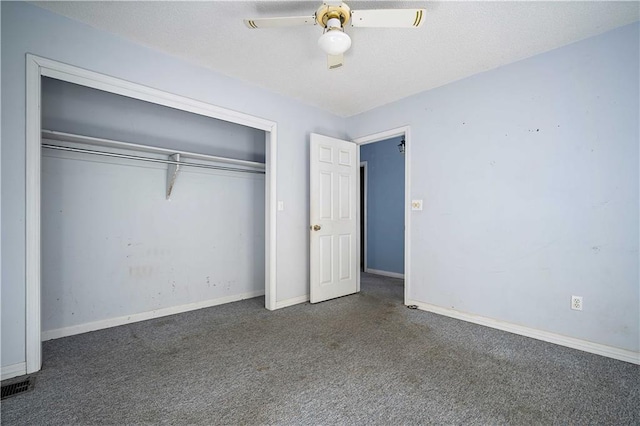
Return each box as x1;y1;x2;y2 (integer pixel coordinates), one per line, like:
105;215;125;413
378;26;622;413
244;1;425;69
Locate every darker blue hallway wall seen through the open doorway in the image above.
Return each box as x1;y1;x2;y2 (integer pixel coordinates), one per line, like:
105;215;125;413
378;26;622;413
360;137;404;274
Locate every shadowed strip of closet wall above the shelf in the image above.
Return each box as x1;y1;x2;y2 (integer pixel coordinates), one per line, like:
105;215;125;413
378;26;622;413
41;77;265;162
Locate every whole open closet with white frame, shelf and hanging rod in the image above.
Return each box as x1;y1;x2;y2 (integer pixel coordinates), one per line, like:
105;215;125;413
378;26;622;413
26;55;277;373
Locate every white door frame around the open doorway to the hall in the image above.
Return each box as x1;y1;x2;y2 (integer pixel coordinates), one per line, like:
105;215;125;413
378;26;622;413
352;126;411;305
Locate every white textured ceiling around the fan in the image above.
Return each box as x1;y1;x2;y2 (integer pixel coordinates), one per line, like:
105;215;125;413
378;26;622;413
35;1;640;116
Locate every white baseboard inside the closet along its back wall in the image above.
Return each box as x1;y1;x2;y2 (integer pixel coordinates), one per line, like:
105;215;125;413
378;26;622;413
42;290;264;340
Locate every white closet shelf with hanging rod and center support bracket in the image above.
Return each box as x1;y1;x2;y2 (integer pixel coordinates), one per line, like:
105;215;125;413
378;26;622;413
41;130;265;200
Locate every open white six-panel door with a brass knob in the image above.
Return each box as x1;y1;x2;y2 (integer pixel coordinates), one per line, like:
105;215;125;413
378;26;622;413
310;133;359;303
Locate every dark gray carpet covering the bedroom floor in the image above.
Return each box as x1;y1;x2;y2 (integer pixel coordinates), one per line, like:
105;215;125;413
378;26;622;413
1;274;640;425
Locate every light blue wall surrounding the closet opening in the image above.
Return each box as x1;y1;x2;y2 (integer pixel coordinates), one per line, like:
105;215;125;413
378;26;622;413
0;2;346;367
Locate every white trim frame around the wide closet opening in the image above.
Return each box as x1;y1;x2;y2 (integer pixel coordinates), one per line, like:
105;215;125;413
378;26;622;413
25;54;277;374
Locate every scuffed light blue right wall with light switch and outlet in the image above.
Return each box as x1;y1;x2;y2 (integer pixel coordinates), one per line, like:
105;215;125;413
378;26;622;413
347;23;640;351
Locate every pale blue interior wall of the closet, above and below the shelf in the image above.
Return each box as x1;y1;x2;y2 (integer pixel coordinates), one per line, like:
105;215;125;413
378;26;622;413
42;78;265;340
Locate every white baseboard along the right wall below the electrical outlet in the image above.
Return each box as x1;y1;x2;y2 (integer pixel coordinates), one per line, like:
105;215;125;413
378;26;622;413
406;300;640;364
